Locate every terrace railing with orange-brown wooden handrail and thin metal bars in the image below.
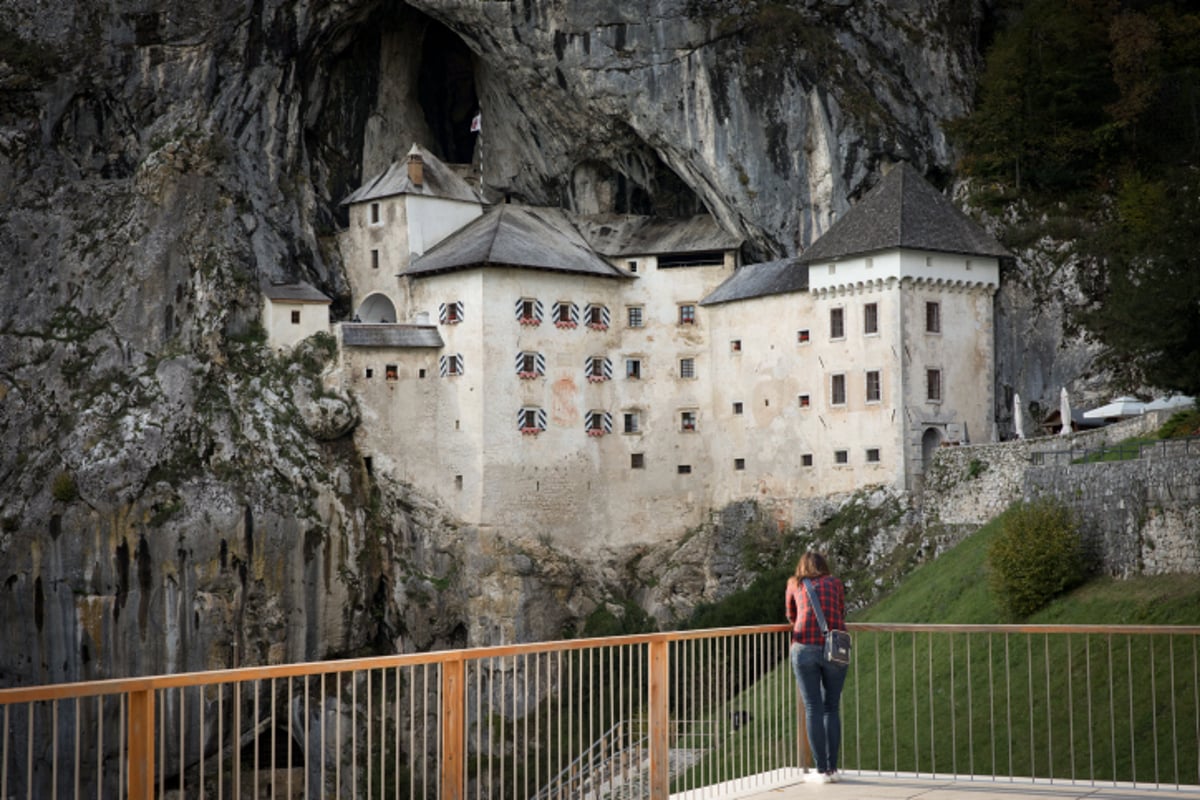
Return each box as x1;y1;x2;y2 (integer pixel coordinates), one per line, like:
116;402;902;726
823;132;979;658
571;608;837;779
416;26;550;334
0;624;1200;800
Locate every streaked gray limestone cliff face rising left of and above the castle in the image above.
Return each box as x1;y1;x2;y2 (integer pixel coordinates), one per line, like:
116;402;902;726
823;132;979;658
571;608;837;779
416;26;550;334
0;0;1012;685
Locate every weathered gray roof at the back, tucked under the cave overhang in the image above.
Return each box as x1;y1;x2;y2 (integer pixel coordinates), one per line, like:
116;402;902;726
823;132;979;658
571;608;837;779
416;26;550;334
576;213;742;257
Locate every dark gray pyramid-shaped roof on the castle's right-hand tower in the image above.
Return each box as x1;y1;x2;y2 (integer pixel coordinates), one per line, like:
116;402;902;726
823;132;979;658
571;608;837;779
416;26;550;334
800;163;1012;264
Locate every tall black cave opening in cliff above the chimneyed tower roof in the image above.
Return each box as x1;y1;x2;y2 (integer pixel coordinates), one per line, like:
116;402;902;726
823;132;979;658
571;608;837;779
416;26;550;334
416;20;479;164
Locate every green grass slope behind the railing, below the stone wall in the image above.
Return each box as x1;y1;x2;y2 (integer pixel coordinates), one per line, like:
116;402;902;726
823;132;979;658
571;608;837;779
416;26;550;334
679;519;1200;786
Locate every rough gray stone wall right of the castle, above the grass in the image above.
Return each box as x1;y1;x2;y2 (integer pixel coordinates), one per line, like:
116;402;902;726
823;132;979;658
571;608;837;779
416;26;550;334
922;411;1200;577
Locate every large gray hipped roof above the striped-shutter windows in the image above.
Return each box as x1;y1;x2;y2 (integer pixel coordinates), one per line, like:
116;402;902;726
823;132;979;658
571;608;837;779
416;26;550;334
404;205;628;278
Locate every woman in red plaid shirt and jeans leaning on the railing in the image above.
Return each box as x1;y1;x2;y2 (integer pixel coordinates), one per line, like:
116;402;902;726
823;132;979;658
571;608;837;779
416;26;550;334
786;551;847;783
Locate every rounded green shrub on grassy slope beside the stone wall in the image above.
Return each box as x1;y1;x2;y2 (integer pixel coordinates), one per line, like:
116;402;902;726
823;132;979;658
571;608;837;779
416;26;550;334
988;499;1088;618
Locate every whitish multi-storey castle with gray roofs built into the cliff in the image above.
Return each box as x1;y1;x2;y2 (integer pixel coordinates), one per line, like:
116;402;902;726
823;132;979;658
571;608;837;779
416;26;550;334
270;148;1007;551
